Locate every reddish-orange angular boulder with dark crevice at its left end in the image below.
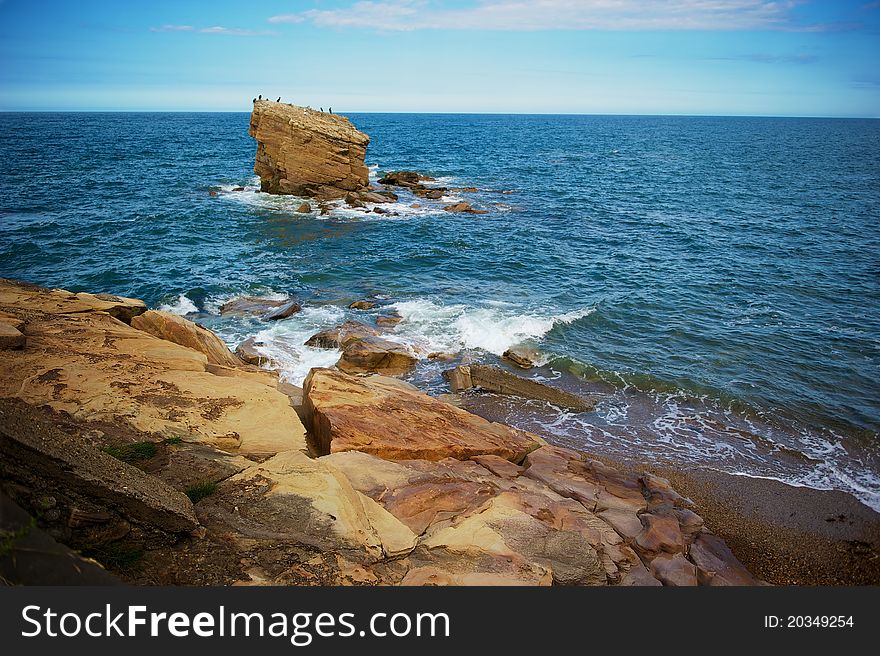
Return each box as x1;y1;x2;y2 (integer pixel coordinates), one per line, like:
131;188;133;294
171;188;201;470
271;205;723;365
303;369;542;462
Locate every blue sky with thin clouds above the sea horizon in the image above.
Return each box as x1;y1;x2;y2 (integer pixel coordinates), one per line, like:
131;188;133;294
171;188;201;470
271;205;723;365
0;0;880;117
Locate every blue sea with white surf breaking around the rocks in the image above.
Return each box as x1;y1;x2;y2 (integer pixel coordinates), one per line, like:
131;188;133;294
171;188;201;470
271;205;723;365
0;113;880;509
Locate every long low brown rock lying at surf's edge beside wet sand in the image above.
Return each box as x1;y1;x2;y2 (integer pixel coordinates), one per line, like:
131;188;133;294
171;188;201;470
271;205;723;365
443;364;596;412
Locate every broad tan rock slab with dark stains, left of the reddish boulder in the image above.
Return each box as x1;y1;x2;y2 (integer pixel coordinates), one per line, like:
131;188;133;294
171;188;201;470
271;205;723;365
0;281;305;458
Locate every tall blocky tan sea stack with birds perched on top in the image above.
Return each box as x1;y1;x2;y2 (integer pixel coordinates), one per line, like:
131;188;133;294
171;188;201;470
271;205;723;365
249;100;370;199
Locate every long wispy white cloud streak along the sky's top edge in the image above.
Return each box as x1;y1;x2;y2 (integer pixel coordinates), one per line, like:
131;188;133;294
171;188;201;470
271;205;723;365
269;0;817;31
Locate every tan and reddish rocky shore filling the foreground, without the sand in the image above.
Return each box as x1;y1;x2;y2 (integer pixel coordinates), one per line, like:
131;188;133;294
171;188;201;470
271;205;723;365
0;280;759;585
